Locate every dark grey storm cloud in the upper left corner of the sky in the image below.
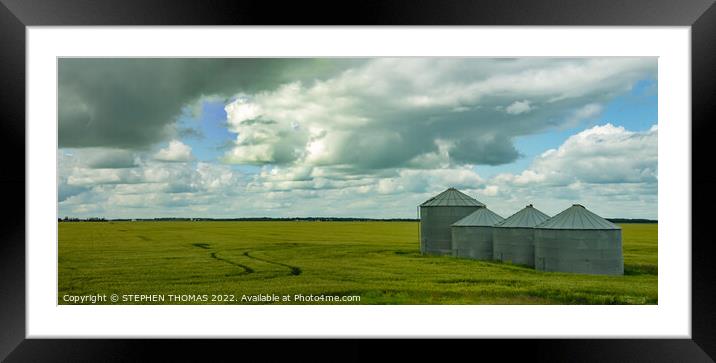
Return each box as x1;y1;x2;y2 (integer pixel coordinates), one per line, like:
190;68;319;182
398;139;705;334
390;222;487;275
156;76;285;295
58;58;356;150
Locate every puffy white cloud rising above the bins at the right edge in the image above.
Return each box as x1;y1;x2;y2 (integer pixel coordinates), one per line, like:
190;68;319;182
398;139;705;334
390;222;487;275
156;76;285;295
485;123;658;218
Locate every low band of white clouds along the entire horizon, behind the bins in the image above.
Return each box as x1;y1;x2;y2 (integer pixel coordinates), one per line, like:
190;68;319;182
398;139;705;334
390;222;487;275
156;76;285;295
60;124;658;218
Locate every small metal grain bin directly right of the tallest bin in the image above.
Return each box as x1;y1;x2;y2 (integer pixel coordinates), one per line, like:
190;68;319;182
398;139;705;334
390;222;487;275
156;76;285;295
452;208;504;260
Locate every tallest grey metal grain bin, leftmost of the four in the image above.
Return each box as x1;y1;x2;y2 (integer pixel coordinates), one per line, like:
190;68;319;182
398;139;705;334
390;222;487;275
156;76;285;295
420;188;485;255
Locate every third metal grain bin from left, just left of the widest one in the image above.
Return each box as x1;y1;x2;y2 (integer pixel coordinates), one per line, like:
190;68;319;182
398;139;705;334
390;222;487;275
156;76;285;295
492;204;549;267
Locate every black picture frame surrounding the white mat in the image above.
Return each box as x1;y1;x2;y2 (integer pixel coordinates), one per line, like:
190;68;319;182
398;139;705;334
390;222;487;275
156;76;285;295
0;0;716;362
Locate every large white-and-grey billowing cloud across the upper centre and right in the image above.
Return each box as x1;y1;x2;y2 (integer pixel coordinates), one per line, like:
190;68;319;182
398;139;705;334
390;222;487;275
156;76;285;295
224;58;656;176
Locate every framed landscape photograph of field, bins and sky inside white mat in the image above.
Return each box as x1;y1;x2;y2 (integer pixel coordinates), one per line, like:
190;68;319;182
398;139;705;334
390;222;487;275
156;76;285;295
58;56;663;305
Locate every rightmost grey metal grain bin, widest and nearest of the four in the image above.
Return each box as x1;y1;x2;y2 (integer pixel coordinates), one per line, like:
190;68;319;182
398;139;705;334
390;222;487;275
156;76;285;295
535;204;624;275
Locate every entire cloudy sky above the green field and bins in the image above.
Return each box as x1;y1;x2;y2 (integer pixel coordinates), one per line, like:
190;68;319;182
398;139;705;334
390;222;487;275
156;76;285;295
57;57;658;219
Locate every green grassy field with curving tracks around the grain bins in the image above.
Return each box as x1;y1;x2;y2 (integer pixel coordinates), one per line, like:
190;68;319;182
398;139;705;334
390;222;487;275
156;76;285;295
58;221;658;304
